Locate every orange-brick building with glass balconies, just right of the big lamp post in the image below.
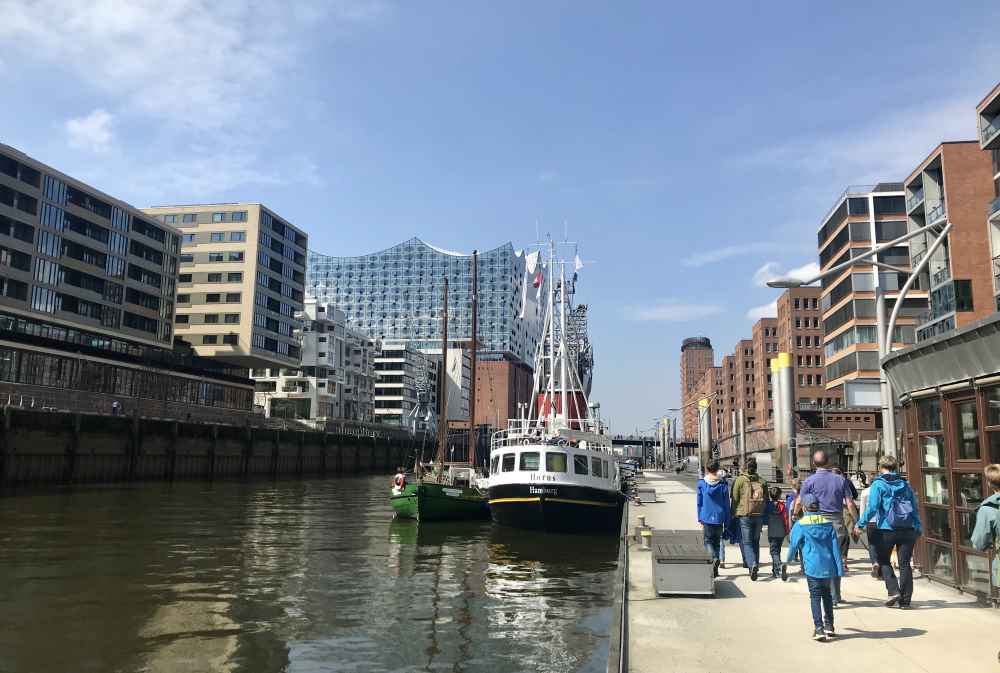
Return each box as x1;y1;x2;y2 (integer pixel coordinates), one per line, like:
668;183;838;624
904;140;996;341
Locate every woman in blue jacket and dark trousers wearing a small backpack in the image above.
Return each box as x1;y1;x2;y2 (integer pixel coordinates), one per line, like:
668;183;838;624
855;456;921;608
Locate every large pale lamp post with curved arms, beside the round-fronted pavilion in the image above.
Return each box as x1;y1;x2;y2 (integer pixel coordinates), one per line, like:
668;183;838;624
767;220;952;456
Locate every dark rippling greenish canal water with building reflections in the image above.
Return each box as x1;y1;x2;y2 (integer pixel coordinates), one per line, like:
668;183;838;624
0;476;617;673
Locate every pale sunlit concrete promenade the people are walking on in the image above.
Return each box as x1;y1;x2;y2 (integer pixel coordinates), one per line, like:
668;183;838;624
628;472;1000;673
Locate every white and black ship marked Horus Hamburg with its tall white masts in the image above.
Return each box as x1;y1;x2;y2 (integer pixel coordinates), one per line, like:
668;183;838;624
487;243;624;534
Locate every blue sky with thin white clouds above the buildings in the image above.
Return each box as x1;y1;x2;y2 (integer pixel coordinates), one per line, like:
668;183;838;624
0;0;1000;432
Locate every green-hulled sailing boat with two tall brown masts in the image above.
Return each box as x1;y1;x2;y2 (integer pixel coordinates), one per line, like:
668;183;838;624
390;252;490;521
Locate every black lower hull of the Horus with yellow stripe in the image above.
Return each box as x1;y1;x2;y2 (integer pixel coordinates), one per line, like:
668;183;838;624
490;483;624;535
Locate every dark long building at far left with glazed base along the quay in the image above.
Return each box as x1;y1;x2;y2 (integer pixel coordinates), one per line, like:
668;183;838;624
0;145;252;417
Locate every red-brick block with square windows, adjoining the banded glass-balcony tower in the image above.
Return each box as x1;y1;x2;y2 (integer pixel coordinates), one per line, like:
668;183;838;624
777;287;843;409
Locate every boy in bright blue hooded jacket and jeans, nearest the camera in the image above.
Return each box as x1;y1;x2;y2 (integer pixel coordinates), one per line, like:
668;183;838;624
781;493;844;642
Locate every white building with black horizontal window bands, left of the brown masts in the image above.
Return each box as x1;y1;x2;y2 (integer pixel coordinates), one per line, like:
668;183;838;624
375;341;441;428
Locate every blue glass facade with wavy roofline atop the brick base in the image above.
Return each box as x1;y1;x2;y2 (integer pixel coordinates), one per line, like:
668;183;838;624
306;238;545;365
